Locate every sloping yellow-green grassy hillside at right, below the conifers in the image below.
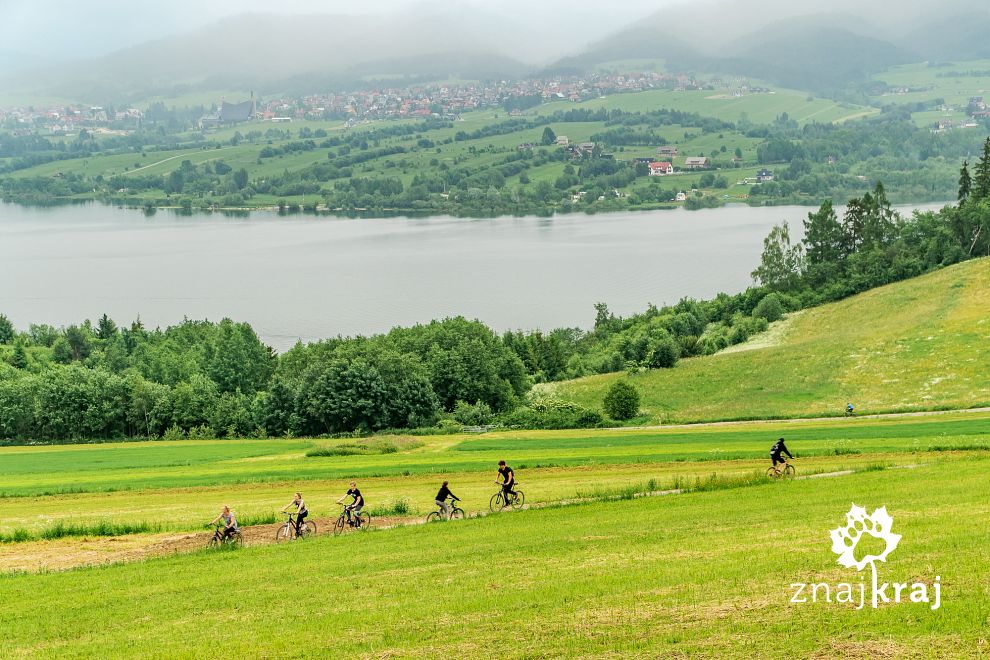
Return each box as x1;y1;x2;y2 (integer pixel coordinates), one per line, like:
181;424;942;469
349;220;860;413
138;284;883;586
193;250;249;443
548;259;990;422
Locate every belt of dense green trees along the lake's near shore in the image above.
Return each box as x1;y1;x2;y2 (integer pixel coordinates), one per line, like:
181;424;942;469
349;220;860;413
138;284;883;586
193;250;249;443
0;144;990;444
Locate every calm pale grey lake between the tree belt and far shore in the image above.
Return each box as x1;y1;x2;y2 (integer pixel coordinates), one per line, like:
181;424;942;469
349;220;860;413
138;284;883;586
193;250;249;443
0;204;940;350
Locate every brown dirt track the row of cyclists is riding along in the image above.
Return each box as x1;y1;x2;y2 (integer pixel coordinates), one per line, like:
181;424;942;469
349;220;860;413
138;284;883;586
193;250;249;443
0;465;917;573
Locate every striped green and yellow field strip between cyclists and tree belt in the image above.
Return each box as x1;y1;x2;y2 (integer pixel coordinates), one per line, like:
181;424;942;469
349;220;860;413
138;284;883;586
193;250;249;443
0;413;990;536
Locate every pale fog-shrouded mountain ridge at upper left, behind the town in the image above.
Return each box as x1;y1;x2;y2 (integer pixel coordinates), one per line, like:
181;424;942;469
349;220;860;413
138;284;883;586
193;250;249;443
5;11;525;102
